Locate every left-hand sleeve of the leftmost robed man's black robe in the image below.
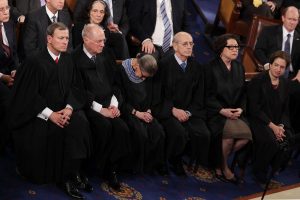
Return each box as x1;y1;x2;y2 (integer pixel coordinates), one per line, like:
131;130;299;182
10;57;47;129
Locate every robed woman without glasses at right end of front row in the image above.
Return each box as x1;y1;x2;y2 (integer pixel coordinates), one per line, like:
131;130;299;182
248;51;292;183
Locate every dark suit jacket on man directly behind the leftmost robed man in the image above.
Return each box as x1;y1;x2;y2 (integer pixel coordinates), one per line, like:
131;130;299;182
23;6;72;56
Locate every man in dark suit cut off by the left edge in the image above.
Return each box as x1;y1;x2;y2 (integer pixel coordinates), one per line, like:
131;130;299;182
0;0;18;151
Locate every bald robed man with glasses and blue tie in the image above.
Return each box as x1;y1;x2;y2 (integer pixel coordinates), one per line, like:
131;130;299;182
159;32;210;175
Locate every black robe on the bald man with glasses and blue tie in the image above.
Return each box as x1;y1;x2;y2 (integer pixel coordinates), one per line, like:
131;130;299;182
159;55;210;165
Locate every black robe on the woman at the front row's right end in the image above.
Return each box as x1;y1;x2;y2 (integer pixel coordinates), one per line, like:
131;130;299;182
247;71;292;173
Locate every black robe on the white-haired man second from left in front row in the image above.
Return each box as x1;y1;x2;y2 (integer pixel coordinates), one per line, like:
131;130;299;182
72;45;130;173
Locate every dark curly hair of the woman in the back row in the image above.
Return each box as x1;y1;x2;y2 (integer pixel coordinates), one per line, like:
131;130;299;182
80;0;110;26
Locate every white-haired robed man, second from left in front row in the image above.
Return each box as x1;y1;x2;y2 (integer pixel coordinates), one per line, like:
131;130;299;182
73;24;130;190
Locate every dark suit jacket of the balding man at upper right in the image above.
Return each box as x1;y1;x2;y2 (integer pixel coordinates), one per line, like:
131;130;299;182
254;25;300;72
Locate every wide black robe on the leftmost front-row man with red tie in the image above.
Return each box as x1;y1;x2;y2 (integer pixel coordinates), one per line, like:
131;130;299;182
10;49;90;183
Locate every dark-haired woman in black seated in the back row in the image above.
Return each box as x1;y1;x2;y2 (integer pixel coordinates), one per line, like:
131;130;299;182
72;0;129;60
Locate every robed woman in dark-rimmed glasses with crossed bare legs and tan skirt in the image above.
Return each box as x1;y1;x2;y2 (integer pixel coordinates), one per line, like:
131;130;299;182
205;34;252;183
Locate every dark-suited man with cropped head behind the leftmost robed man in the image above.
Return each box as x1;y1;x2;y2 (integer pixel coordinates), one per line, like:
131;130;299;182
23;0;72;56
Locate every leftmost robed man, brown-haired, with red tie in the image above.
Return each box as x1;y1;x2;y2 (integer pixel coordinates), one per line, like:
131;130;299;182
10;23;92;199
